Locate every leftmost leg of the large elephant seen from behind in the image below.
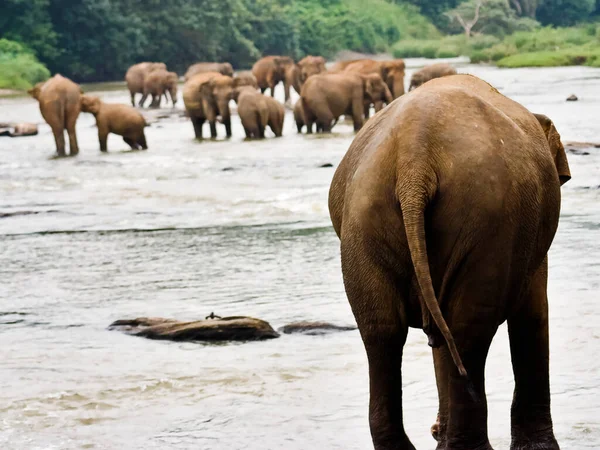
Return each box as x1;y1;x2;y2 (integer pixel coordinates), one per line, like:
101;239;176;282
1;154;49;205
341;230;415;450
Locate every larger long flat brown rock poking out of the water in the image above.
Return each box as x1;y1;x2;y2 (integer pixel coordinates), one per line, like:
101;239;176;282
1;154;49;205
108;315;279;341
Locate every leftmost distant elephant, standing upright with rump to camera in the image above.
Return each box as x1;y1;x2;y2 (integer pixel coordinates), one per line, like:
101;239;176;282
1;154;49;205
28;74;83;157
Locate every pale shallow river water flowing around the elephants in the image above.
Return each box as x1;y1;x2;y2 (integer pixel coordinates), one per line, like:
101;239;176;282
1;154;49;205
0;60;600;450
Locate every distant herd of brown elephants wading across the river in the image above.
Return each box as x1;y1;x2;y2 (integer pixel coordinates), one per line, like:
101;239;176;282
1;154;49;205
23;56;456;156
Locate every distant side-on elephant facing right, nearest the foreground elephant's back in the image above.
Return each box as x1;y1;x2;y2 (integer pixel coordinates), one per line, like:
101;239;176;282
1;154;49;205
300;72;389;133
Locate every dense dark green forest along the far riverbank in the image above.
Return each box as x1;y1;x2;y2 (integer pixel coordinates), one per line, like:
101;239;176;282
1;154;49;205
0;0;600;84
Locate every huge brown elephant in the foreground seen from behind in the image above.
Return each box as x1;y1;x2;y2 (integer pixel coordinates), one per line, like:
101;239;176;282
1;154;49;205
329;75;570;450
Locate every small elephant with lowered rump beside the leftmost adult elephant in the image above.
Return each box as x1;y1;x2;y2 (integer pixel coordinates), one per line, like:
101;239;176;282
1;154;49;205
81;95;148;152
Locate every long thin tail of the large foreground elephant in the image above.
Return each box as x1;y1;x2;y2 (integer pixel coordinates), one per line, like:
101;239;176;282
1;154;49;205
397;174;467;378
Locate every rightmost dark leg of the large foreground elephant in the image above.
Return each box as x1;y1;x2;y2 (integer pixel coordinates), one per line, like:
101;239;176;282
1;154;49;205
508;261;559;450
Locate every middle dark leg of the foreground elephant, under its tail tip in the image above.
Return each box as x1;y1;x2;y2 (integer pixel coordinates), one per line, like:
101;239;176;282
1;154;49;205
434;260;509;450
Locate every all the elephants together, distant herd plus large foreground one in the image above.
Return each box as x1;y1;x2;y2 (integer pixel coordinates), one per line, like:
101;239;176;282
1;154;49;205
24;51;571;450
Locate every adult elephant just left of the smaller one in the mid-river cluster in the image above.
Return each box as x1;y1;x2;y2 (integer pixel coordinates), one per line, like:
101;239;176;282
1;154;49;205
183;72;235;139
